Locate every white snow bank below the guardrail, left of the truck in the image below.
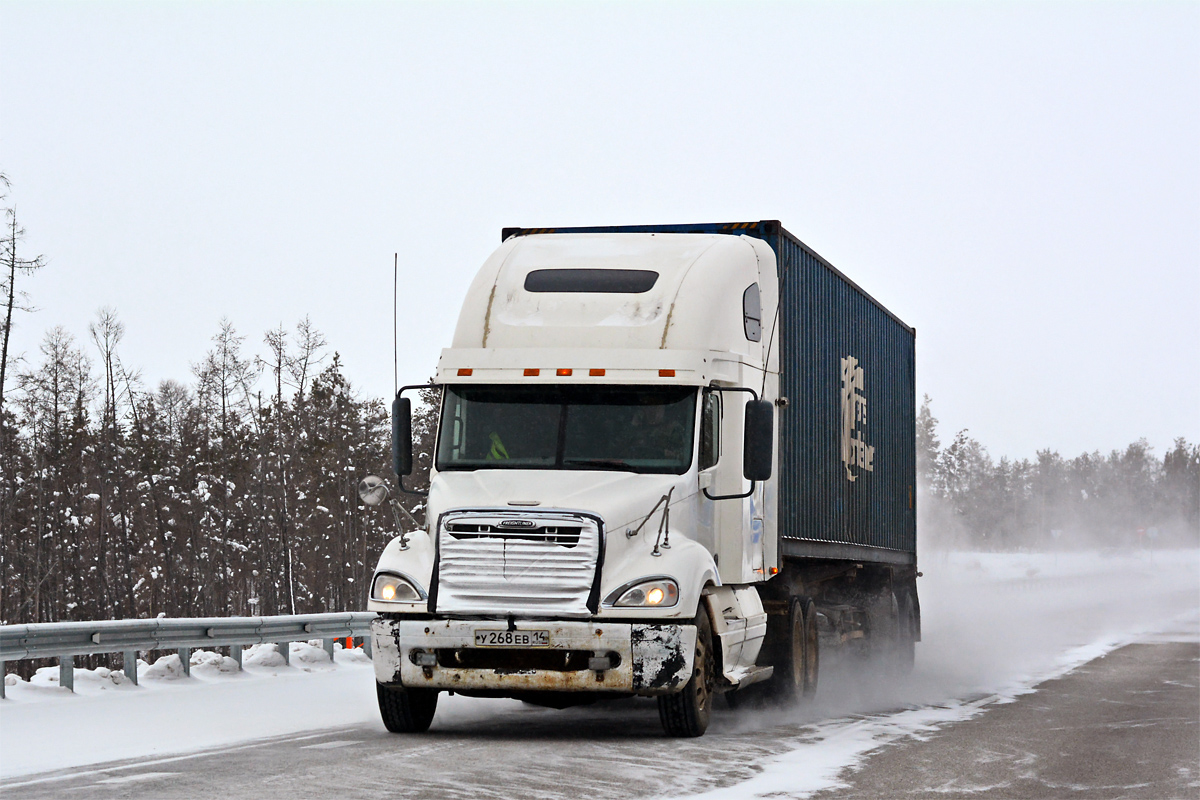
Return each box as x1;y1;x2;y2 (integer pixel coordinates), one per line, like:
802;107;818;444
0;640;378;778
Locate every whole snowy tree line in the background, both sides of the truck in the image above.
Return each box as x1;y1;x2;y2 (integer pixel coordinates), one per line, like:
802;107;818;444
0;321;1200;624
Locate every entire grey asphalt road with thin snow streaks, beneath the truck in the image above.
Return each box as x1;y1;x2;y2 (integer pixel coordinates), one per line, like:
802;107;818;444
0;640;1200;800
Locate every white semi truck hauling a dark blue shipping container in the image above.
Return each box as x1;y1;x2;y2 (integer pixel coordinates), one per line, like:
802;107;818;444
361;221;920;736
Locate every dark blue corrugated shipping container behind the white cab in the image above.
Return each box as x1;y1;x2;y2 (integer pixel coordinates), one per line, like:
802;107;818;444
503;221;917;564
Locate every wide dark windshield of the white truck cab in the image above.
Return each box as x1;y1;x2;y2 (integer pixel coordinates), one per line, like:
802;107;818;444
438;386;696;475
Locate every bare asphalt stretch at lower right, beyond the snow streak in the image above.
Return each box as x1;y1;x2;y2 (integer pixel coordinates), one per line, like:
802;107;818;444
814;640;1200;800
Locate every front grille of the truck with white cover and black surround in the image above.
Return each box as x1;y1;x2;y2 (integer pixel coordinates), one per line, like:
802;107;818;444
434;511;601;618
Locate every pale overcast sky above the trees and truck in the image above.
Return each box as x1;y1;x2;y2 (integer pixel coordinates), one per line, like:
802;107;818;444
0;1;1200;457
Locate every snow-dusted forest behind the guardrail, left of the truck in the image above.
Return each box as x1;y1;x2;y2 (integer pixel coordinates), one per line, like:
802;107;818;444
0;311;441;622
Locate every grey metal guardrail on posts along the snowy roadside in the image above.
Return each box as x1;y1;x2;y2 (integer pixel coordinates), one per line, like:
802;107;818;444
0;612;376;698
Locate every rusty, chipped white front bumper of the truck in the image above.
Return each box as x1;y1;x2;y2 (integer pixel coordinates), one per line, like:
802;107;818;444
371;618;696;694
